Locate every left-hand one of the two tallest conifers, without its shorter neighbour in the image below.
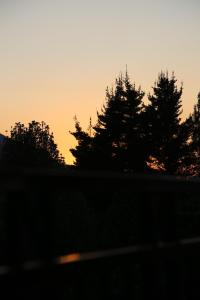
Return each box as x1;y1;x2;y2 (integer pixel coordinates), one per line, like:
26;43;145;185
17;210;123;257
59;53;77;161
94;72;147;171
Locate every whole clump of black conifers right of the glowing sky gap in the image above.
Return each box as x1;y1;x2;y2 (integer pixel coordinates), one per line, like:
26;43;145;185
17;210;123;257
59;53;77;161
71;72;200;175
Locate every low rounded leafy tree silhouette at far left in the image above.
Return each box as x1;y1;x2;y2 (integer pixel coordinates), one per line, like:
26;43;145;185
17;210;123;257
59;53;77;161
1;121;64;167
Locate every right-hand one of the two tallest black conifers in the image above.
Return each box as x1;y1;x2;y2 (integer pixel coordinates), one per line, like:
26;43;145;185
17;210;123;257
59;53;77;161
146;72;190;174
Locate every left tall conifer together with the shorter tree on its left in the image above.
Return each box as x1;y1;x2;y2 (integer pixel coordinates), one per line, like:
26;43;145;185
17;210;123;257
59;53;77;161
71;72;147;171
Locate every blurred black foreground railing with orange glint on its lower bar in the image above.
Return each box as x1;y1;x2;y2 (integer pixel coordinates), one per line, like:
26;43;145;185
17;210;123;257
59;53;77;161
0;170;200;300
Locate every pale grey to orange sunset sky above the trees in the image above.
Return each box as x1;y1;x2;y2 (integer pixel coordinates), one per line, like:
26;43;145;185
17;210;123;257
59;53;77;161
0;0;200;164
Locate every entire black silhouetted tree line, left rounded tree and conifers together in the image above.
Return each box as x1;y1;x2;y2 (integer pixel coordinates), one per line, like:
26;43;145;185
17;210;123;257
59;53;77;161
0;72;200;176
